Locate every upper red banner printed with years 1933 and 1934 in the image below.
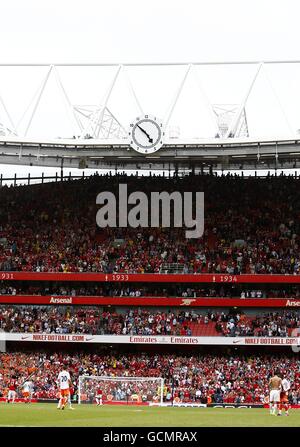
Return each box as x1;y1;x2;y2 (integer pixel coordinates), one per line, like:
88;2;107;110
0;272;300;284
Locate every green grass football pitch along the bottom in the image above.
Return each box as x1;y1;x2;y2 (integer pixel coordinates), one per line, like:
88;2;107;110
0;403;300;427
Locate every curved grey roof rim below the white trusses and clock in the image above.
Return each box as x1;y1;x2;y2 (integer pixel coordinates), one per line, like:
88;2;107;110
0;138;300;170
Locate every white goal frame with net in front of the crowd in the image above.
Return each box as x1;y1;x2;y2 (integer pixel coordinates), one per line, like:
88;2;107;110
78;375;164;405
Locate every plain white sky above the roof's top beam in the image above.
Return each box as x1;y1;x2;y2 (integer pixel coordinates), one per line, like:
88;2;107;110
0;0;300;62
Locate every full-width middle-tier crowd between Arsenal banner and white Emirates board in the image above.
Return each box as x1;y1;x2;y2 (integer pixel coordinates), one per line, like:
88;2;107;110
0;305;300;337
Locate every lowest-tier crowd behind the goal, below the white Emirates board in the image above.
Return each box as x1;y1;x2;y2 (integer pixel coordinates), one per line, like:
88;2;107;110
0;352;300;404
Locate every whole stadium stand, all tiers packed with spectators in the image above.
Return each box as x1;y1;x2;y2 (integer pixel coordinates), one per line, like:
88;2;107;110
0;175;300;412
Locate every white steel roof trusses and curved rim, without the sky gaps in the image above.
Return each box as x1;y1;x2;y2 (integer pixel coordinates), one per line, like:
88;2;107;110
0;61;300;171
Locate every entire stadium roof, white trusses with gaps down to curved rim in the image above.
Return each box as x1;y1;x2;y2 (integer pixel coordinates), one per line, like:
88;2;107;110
0;64;300;170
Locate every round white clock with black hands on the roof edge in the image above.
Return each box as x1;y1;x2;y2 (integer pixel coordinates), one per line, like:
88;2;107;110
129;115;164;154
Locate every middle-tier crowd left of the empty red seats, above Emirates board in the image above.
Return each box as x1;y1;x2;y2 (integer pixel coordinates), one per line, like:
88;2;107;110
0;305;197;336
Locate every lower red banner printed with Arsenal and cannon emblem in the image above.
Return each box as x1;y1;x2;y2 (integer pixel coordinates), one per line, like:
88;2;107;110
0;295;300;308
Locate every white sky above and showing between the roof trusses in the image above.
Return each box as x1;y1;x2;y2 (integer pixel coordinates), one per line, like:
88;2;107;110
0;0;300;180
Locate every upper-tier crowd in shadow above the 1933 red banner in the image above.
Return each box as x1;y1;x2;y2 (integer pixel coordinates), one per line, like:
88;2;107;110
0;175;300;274
